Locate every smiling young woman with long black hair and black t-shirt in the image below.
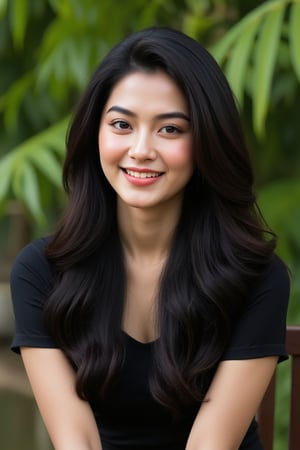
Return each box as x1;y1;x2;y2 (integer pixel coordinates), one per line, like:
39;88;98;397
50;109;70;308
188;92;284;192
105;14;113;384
12;28;289;450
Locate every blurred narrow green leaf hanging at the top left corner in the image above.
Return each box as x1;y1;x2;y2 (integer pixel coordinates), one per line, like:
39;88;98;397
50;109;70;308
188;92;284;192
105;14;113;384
9;0;29;49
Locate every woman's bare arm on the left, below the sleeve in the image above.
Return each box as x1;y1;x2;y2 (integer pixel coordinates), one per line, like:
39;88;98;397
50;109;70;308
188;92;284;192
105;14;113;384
21;347;102;450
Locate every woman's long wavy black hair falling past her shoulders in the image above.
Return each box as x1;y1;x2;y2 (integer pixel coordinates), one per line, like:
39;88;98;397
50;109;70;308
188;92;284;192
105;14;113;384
45;28;275;411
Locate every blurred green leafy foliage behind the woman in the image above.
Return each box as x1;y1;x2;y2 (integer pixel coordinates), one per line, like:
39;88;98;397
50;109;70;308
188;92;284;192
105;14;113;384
0;0;300;450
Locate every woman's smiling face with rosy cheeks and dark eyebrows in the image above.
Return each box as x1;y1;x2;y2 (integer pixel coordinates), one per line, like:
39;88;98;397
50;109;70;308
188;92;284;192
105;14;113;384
99;71;194;208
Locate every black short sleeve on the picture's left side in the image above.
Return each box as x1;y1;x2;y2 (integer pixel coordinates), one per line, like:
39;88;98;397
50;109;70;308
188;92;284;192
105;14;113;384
10;238;57;353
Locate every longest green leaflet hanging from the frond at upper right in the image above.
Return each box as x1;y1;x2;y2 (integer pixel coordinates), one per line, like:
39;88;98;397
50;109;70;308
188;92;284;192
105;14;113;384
253;2;284;136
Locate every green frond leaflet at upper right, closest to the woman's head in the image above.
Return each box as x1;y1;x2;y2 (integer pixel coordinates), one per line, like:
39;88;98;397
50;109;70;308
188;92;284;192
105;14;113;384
226;17;261;105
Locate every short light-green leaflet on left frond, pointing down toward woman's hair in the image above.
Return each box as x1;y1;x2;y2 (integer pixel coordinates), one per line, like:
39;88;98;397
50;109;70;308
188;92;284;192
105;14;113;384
29;148;62;188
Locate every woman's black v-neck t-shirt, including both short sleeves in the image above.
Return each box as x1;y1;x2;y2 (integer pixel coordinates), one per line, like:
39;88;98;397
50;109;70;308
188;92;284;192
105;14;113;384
11;238;289;450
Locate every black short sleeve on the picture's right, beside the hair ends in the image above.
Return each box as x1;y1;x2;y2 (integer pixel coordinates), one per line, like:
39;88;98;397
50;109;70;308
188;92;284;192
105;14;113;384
222;256;290;361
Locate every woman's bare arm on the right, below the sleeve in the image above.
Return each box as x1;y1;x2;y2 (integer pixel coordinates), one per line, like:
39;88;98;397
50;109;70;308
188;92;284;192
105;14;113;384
186;356;278;450
